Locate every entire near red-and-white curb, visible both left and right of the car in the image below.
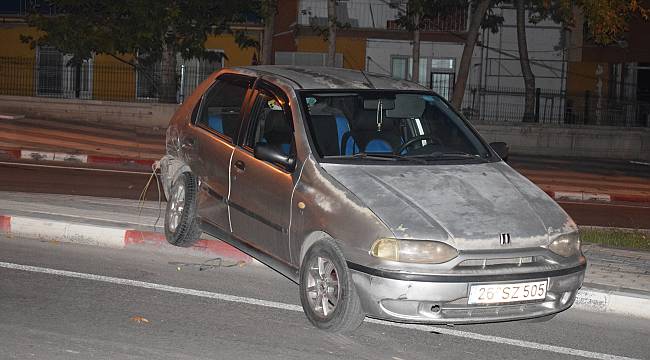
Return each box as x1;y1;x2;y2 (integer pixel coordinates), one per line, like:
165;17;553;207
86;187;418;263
0;215;650;319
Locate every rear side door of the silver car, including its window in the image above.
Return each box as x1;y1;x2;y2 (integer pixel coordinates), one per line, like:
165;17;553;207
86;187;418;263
185;74;254;233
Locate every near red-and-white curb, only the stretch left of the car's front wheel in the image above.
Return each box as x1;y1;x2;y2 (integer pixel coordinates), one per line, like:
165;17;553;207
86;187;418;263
0;215;252;263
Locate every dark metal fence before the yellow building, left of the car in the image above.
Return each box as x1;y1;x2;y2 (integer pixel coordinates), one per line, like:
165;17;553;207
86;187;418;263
0;56;221;102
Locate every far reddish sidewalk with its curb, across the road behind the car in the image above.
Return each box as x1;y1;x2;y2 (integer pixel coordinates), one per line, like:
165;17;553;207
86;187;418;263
0;114;650;203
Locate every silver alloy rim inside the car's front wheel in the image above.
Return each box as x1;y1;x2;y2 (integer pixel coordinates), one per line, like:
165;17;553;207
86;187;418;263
307;256;340;318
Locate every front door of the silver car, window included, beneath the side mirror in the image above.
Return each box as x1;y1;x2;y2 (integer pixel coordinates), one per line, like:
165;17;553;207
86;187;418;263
229;80;295;262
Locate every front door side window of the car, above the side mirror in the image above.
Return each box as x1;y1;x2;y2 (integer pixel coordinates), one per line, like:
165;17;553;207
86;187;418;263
244;88;295;159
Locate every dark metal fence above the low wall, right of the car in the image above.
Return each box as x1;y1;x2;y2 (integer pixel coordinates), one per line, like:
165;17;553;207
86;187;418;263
461;88;650;127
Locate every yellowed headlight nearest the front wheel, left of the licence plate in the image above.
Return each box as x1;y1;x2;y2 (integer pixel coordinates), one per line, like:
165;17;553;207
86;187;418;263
370;238;458;264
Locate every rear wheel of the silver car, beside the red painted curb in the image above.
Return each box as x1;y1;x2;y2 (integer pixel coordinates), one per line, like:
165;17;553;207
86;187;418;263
165;172;201;247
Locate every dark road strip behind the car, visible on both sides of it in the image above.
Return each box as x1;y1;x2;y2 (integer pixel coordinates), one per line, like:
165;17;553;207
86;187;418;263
0;163;650;229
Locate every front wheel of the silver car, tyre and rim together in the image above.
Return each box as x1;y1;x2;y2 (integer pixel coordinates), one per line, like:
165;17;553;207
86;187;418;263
300;239;365;333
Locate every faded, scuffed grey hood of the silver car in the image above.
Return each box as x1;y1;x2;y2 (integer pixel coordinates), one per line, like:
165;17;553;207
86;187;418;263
321;162;577;250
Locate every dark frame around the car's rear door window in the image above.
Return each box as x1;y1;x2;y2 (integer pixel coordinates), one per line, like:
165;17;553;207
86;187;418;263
191;73;255;145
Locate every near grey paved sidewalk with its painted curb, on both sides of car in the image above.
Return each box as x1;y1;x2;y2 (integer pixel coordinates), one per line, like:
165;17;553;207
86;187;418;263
0;192;650;319
